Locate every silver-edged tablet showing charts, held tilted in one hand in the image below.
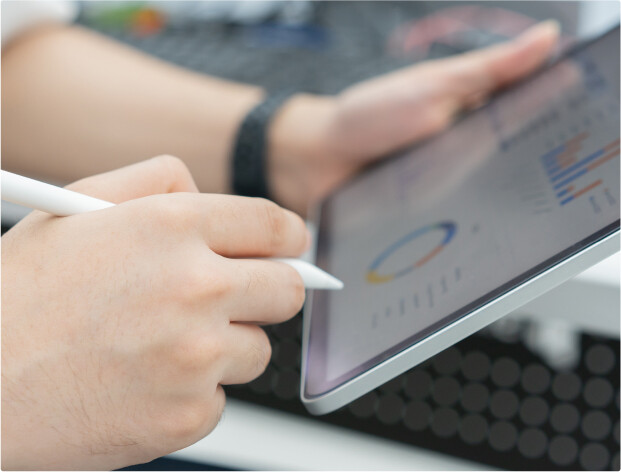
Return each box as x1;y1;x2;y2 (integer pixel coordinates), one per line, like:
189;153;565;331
301;27;620;414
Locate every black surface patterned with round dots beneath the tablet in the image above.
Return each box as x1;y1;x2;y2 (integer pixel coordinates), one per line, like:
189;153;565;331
227;319;619;469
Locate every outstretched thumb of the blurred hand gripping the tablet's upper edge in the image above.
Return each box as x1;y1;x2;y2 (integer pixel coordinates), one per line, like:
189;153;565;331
436;20;559;108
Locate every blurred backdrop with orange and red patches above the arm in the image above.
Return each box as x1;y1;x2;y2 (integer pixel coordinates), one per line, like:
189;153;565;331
80;1;618;93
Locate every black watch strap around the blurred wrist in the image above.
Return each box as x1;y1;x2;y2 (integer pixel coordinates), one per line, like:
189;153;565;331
231;90;295;198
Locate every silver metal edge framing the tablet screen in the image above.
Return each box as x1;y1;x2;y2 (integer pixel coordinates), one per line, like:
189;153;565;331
300;27;620;414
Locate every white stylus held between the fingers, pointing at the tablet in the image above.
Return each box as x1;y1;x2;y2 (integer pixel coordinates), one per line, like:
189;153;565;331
2;170;343;290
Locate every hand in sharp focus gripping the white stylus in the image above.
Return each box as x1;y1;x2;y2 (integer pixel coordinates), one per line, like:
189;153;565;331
2;157;308;470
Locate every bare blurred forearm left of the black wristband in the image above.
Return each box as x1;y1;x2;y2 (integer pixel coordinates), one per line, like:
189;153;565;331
2;23;263;192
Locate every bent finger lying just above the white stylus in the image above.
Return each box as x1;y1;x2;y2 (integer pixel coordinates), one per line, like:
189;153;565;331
66;156;198;203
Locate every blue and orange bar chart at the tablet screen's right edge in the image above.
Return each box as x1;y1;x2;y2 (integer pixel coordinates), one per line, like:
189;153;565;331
541;132;619;206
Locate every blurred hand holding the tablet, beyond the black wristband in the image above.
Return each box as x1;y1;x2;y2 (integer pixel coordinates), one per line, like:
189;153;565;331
269;22;558;214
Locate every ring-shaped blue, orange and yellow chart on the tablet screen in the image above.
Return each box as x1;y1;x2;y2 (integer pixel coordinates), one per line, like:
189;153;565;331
366;221;457;284
